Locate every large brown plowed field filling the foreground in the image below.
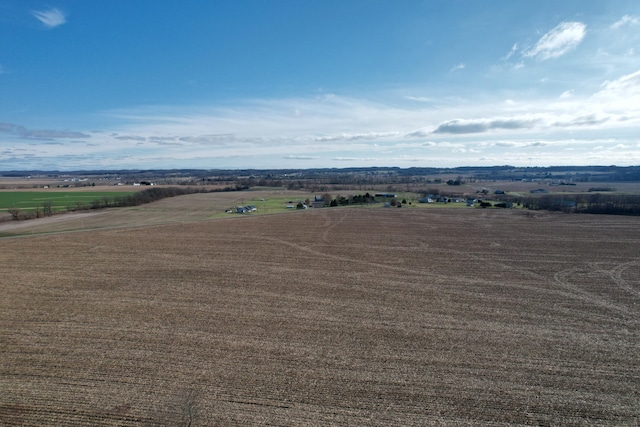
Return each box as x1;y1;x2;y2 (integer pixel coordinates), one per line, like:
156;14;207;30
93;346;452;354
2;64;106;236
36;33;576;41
0;208;640;426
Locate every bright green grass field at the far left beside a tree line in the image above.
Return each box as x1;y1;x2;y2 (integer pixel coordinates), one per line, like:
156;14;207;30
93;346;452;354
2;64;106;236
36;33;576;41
0;191;134;212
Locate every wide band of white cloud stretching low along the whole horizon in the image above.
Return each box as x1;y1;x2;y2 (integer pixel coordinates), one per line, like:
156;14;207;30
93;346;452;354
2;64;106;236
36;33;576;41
5;70;640;169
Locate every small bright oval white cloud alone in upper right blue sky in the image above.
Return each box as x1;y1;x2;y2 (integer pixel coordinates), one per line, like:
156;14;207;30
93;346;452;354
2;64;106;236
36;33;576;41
522;22;587;61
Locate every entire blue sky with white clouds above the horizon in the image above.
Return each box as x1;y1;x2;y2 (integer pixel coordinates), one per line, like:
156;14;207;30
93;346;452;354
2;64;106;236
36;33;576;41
0;0;640;171
